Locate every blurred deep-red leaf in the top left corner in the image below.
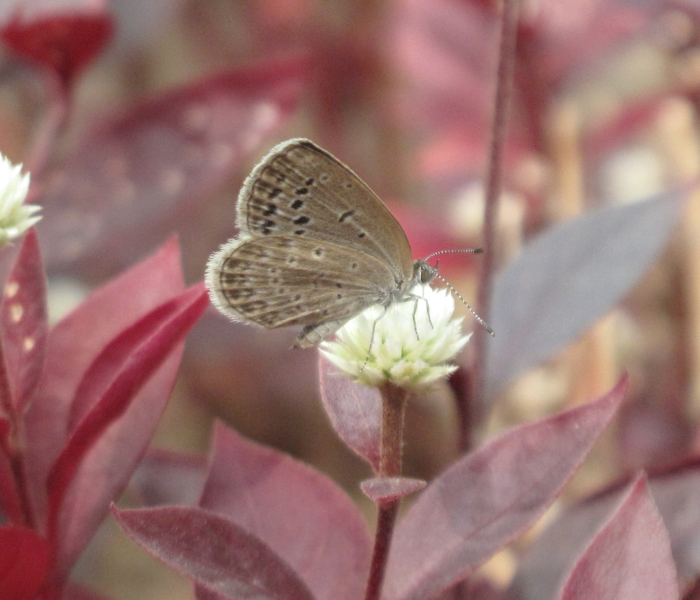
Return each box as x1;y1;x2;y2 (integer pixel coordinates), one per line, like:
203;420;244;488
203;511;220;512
0;8;114;87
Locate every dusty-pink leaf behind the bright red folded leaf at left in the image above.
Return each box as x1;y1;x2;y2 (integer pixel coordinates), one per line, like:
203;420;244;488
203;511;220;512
24;239;183;526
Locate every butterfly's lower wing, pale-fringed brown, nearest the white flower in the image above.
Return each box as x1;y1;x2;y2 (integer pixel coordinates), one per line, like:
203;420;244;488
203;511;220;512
207;235;395;328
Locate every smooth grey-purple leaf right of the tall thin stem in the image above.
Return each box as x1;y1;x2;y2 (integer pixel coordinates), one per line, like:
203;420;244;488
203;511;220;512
486;192;685;397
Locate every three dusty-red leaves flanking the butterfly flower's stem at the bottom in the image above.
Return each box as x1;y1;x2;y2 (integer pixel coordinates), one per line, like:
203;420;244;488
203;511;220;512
114;382;626;600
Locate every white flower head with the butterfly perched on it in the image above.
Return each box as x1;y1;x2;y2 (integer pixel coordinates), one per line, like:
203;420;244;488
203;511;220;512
321;285;471;389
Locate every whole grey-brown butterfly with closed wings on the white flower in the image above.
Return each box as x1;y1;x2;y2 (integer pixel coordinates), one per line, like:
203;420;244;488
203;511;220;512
205;138;488;348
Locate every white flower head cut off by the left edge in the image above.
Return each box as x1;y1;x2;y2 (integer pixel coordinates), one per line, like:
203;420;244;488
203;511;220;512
0;154;41;246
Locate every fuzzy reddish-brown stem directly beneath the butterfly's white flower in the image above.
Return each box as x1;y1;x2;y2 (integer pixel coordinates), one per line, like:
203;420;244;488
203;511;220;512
365;383;408;600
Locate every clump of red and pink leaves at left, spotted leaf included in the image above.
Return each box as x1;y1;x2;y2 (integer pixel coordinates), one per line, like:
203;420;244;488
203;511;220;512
0;230;208;597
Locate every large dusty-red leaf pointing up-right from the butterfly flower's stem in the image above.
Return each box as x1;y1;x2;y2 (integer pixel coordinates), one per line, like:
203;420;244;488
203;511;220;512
385;378;627;600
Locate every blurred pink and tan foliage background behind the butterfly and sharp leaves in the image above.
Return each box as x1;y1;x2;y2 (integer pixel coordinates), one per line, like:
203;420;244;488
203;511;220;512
0;0;700;598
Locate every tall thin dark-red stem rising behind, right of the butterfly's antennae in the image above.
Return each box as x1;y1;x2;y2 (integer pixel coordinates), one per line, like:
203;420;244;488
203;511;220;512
470;0;519;440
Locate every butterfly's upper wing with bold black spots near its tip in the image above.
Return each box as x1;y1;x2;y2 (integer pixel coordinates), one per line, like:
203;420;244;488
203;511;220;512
238;139;413;284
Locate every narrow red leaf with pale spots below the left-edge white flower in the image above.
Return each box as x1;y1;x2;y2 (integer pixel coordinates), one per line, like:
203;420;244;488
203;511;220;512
0;228;48;415
